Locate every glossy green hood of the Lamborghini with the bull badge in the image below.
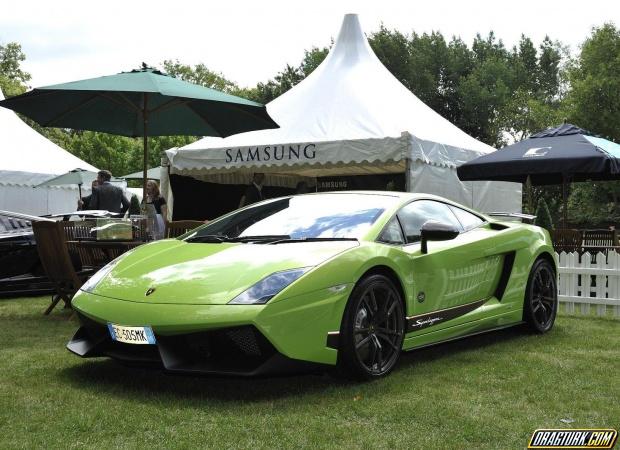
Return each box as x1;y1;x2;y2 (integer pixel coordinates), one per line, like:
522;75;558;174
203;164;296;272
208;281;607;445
93;240;359;305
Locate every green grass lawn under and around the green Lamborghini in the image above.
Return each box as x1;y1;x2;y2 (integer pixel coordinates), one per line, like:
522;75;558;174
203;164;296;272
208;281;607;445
0;297;620;449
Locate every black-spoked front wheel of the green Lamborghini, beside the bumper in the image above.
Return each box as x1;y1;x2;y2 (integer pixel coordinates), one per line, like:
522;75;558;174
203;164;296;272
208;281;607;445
338;275;405;380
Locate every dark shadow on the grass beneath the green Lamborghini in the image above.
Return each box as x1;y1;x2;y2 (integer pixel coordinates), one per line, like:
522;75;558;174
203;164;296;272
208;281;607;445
58;327;531;405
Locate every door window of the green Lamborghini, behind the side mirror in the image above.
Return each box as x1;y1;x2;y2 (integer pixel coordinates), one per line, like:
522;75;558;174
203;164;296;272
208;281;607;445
398;200;463;243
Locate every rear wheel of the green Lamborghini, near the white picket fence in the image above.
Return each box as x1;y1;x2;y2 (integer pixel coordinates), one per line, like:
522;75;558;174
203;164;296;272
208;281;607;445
523;259;558;333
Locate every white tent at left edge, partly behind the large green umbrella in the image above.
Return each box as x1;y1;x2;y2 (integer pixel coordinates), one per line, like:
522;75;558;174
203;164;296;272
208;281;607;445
0;91;98;215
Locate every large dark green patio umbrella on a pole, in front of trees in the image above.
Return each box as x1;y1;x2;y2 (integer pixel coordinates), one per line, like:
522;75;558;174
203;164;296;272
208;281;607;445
0;64;278;198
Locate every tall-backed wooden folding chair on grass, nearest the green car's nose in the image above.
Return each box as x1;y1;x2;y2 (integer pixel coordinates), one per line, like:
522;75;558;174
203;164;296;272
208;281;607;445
32;221;87;314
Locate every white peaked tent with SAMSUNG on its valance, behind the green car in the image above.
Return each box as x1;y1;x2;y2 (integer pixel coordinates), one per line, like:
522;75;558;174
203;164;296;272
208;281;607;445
161;14;521;216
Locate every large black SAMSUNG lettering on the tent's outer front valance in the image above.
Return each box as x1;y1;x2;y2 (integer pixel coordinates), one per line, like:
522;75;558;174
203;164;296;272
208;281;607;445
226;144;316;163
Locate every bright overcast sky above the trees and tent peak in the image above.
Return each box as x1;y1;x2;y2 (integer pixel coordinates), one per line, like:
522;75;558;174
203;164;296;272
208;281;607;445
0;0;620;87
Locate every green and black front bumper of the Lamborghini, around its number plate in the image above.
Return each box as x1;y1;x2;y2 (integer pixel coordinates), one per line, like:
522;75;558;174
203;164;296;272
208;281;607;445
67;289;349;376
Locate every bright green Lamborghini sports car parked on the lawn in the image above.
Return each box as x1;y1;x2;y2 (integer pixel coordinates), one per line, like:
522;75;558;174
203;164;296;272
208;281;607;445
67;192;558;379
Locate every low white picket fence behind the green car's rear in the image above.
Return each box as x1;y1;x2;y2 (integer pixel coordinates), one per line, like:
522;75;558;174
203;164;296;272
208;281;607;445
558;251;620;316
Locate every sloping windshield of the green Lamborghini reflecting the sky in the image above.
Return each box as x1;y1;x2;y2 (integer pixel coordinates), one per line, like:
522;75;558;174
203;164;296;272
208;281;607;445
186;194;398;242
